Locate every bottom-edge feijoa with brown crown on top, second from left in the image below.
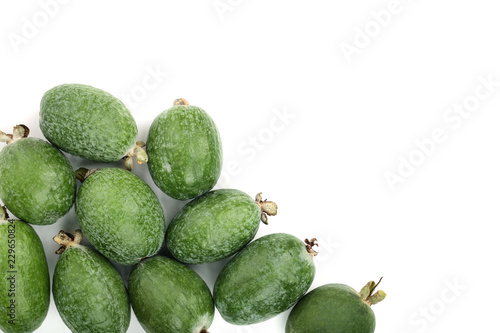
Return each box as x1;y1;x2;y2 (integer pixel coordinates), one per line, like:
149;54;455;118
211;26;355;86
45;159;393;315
52;230;130;333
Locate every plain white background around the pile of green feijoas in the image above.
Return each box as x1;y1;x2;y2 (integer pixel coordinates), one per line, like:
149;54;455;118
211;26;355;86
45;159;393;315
0;0;500;333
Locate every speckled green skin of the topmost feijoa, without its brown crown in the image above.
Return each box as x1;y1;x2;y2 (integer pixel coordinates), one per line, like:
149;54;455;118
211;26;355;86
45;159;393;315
40;84;137;162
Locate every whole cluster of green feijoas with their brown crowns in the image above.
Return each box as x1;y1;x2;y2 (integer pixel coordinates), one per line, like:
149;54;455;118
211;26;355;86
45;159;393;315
0;84;385;333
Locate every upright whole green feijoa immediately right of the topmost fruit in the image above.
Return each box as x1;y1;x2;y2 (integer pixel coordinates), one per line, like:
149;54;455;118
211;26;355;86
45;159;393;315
146;99;222;200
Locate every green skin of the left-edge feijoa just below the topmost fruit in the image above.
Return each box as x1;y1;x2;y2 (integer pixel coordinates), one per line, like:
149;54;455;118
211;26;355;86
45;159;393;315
0;138;76;224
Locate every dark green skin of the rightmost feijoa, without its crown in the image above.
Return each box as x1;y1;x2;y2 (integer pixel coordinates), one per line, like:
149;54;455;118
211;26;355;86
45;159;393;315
286;284;375;333
